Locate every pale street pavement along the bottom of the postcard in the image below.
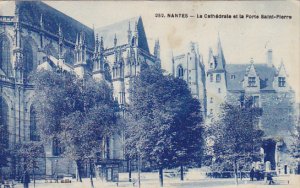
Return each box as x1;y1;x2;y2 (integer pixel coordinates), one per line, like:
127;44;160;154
15;173;300;188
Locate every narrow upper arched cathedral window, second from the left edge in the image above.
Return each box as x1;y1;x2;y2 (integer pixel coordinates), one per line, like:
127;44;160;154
23;41;34;78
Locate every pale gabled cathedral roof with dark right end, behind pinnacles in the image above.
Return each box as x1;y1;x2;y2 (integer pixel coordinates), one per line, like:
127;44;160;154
95;17;149;52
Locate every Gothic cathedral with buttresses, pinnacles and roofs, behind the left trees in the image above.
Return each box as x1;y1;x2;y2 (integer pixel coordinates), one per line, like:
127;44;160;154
0;1;160;178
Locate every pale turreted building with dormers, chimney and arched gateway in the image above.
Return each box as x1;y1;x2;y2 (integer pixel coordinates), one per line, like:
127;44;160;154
172;38;297;174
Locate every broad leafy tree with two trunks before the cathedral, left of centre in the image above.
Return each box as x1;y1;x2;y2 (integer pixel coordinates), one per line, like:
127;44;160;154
33;70;119;187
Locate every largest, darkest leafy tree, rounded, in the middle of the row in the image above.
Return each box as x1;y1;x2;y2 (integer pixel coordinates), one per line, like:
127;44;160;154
125;67;203;186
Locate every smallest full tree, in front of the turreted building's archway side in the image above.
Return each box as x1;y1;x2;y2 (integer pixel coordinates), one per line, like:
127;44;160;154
206;99;264;184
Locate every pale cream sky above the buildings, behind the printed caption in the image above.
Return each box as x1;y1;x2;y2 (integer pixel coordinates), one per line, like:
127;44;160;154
1;1;300;102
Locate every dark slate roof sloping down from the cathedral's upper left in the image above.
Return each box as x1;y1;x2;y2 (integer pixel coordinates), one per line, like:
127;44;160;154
17;1;95;50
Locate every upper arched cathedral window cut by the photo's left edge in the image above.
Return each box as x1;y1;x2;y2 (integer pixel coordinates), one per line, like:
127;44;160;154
0;35;12;77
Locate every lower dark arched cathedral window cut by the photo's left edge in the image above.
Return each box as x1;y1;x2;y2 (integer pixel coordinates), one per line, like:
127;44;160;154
0;96;9;148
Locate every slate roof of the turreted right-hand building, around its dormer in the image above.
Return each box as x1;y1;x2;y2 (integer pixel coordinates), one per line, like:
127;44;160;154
226;64;277;91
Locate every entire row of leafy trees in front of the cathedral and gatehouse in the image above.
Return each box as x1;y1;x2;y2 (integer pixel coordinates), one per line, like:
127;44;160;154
0;66;274;187
